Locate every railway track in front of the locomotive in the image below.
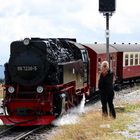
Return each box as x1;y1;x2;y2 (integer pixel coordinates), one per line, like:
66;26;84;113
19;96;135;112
0;126;44;140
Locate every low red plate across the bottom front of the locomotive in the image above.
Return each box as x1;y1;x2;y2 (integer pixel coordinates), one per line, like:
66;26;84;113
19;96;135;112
0;115;55;126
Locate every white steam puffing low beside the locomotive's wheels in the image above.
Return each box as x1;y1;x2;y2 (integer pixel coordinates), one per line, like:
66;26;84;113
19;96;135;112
52;94;85;126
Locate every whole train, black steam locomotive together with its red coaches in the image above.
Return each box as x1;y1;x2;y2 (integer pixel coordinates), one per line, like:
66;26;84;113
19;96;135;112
0;38;140;126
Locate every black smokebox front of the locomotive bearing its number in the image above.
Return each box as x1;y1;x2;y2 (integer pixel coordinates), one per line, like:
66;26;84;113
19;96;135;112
9;41;46;86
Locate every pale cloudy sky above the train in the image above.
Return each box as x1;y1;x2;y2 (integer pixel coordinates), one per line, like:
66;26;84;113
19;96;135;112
0;0;140;65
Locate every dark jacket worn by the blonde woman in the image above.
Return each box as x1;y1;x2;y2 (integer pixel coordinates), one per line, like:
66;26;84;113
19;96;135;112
98;70;114;95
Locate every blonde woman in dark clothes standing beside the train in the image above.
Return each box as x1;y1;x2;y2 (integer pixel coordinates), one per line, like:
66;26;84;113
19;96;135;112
98;61;116;119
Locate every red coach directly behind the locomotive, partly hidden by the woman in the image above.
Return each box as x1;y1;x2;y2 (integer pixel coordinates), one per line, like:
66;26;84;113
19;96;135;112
84;43;117;91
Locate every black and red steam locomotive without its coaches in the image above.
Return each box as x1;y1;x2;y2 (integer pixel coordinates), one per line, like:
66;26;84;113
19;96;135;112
0;38;88;126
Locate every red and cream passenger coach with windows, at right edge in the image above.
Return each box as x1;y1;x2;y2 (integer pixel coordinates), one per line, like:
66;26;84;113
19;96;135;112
112;44;140;83
